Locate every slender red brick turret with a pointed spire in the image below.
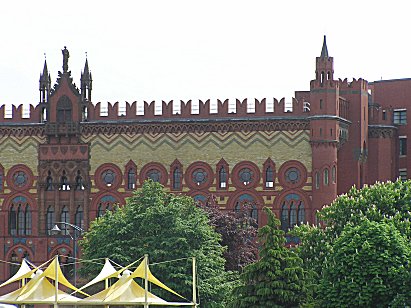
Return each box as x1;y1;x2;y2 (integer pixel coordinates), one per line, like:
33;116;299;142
309;36;340;211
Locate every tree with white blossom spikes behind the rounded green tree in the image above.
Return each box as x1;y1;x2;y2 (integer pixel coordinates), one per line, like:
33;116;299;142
292;181;411;306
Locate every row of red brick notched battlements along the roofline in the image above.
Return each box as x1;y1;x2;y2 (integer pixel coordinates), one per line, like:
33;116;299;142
0;98;309;124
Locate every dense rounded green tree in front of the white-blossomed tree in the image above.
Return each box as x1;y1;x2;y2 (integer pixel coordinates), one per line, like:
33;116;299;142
319;219;411;307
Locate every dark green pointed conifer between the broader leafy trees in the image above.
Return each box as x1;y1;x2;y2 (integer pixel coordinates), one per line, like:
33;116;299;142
230;208;305;308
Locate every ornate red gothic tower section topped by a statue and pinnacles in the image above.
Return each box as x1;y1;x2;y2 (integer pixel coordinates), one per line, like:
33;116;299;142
38;47;91;236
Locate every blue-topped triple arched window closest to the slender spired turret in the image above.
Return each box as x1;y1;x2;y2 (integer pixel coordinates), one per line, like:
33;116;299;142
281;194;305;232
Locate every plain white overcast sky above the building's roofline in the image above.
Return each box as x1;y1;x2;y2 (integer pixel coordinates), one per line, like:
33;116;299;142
0;0;411;104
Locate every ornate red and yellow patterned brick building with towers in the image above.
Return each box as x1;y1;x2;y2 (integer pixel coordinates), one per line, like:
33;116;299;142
0;38;411;282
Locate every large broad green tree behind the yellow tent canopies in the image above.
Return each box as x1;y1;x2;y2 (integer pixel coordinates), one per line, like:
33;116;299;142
81;181;228;307
